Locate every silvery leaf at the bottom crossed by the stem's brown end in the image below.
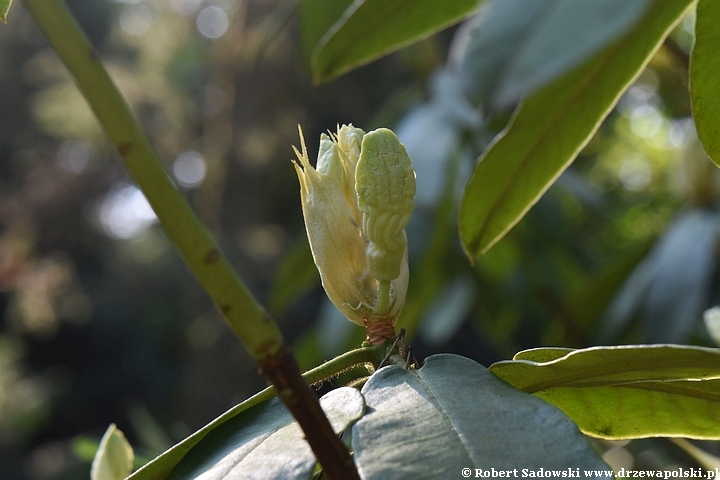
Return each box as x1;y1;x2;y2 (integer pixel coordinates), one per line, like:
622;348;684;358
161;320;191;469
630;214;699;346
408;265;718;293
167;387;365;480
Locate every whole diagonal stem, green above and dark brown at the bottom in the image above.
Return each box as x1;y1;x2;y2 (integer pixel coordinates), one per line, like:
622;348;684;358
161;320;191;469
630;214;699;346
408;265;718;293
25;0;359;480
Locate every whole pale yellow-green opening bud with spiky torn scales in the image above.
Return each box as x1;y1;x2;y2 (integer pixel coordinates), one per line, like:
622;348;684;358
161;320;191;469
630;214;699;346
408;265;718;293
293;125;415;345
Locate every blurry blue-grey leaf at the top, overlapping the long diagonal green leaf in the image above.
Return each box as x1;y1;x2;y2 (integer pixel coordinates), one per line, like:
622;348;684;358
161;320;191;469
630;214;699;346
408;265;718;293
461;0;648;108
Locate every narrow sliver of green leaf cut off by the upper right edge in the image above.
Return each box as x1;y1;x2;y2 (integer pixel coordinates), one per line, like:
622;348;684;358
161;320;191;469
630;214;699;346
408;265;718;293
690;0;720;165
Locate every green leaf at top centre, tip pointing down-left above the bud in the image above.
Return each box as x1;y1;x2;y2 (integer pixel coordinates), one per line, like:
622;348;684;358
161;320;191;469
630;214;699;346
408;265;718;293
312;0;480;83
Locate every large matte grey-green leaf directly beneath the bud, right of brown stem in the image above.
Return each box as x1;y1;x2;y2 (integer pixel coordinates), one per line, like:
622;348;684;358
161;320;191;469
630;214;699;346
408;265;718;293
352;355;608;480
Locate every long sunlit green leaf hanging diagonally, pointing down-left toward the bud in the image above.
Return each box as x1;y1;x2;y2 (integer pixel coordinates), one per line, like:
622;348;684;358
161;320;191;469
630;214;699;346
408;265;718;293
459;0;693;260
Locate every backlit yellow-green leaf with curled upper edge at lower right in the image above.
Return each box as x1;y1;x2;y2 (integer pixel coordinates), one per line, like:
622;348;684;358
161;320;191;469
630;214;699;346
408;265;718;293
490;345;720;440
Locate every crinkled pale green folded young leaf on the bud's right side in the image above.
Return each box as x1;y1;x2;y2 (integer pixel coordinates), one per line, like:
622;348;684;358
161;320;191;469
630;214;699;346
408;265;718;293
355;128;415;281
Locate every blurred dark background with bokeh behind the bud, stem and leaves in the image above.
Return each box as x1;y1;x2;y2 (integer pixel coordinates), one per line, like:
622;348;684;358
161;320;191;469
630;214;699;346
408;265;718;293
0;0;720;480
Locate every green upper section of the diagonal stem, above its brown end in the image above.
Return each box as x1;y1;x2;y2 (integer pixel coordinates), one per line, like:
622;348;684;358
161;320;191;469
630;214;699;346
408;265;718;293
25;0;283;361
